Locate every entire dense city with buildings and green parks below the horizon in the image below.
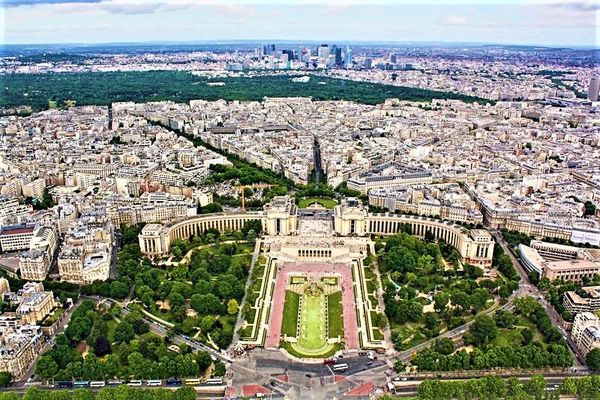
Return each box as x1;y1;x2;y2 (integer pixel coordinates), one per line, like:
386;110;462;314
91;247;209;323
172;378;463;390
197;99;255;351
0;0;600;400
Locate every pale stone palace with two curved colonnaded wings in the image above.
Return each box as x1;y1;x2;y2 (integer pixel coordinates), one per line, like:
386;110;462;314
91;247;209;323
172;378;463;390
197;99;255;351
139;196;494;267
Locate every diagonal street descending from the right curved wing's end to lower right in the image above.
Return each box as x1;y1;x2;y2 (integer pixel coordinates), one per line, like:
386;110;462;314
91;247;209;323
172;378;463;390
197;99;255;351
490;230;587;369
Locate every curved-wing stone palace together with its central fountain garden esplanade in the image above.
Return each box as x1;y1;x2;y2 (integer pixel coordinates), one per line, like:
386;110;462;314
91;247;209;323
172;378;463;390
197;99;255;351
139;196;494;362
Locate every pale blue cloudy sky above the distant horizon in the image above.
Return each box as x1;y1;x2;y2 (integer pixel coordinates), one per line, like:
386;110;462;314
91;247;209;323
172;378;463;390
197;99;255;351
0;0;600;47
